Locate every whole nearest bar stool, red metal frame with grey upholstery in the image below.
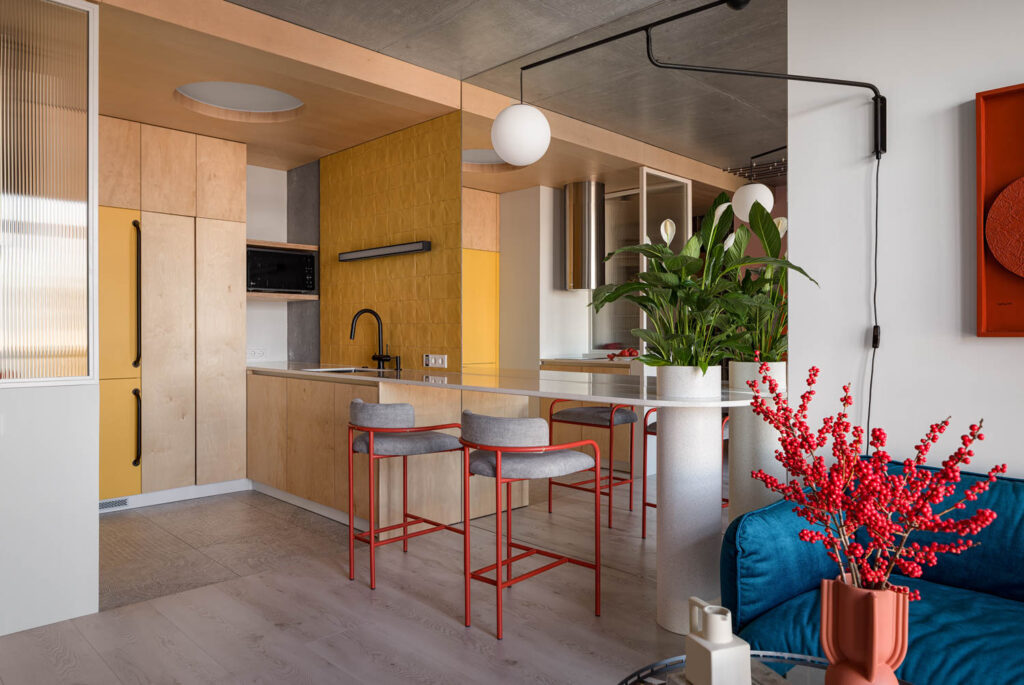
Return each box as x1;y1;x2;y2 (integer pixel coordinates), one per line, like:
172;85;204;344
462;412;601;640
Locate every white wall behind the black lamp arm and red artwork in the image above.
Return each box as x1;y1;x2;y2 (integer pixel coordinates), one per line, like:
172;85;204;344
788;0;1024;476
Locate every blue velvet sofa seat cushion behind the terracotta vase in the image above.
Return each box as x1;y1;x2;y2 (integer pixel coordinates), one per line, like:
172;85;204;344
739;579;1024;685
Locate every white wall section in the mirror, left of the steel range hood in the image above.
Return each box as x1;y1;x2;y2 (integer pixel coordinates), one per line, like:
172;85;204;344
499;186;590;369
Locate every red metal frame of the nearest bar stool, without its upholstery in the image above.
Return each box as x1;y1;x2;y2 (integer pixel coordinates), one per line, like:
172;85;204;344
460;438;601;640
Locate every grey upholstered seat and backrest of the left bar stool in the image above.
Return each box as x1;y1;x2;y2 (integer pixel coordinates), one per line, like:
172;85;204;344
348;398;462;457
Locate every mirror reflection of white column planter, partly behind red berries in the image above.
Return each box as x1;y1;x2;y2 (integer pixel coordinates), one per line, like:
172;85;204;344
729;361;786;521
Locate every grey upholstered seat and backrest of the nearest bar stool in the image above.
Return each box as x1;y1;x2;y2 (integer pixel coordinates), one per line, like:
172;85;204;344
462;412;594;478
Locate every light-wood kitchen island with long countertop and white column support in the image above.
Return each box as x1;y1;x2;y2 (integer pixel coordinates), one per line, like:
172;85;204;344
248;362;751;633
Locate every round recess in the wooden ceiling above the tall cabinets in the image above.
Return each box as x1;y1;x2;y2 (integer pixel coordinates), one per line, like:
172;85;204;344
174;81;303;123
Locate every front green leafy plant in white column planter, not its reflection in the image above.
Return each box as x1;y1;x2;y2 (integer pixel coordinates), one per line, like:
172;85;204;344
591;192;810;373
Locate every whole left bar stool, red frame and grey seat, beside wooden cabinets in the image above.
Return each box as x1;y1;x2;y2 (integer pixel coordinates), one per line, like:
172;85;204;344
348;398;463;590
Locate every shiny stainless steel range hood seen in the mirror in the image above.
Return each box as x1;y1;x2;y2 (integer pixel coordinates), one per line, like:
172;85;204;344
565;181;605;290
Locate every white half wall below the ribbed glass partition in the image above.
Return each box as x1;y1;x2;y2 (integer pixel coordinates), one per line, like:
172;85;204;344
0;383;99;635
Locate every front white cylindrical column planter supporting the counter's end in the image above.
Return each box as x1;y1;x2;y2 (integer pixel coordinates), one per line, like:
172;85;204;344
657;367;722;634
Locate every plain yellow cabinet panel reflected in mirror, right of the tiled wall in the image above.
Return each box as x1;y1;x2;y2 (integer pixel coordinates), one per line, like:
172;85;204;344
462;250;499;365
